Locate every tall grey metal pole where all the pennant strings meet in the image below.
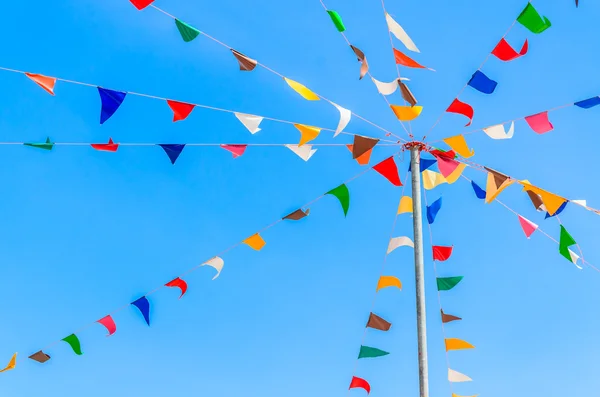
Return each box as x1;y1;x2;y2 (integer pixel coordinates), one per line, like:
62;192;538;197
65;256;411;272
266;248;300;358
410;145;429;397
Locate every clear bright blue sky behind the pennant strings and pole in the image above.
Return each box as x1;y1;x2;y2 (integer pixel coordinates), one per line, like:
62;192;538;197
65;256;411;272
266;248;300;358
0;0;600;397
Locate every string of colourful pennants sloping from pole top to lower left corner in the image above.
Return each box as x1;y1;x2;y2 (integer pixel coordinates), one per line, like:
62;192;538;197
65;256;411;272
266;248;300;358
0;155;403;372
